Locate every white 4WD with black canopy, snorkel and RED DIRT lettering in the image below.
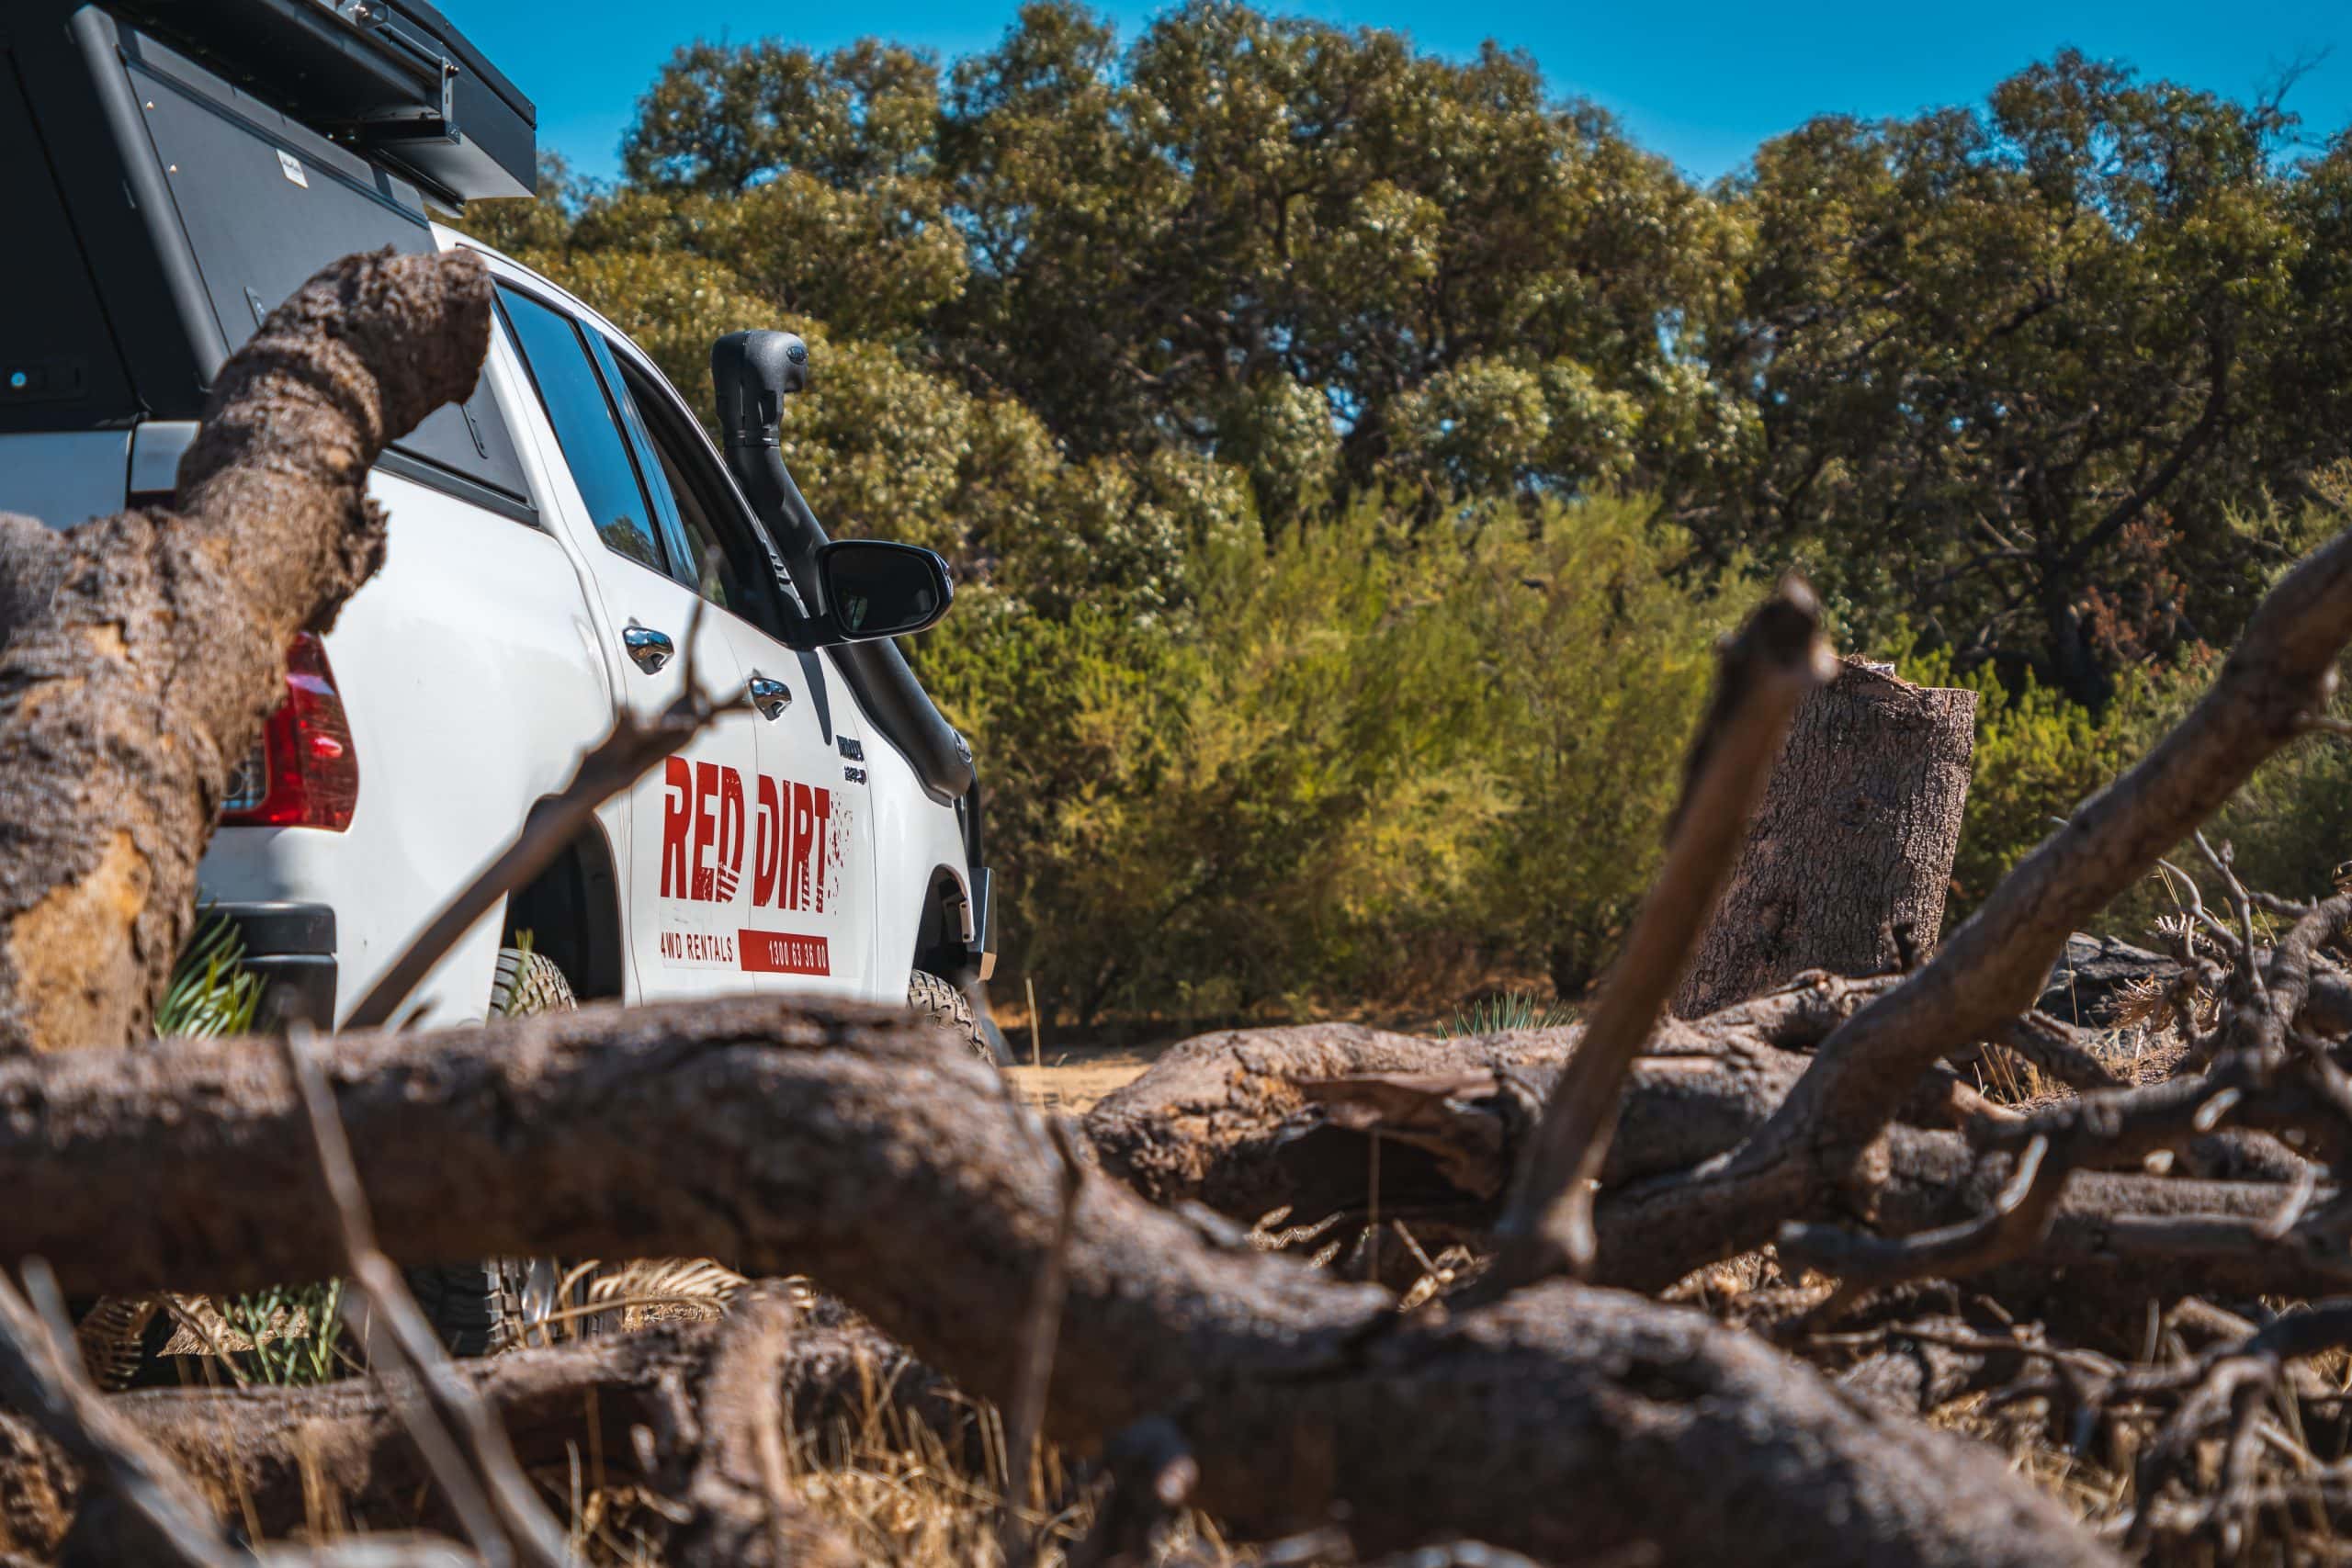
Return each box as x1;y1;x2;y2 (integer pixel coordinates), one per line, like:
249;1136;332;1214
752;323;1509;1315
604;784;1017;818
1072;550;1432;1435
0;0;990;1066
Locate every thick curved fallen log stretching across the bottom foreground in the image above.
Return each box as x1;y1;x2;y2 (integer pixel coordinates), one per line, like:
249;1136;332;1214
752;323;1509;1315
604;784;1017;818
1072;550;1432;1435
0;999;2109;1563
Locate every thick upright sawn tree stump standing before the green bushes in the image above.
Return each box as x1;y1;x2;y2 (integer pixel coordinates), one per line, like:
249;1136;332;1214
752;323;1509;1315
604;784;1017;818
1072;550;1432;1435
1675;660;1975;1018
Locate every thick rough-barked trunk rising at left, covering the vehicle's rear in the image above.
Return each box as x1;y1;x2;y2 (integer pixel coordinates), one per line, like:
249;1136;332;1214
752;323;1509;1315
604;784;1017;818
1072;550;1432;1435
0;252;489;1051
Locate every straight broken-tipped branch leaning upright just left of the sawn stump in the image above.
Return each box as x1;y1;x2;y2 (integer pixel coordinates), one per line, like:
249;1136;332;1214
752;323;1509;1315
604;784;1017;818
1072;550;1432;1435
1473;576;1837;1300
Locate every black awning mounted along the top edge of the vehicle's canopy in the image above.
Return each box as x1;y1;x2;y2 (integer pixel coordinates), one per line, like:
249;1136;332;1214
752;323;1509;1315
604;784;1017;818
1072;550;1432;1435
104;0;538;205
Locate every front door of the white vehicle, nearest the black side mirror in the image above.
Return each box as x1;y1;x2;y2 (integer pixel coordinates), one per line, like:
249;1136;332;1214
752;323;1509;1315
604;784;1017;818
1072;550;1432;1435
597;339;875;997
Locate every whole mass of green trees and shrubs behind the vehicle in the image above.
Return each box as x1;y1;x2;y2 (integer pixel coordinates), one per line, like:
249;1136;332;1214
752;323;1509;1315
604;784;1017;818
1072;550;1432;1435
466;0;2352;1022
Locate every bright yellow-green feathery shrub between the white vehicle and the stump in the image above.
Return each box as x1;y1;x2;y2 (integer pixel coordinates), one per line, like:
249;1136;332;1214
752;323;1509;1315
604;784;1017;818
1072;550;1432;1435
920;501;1738;1025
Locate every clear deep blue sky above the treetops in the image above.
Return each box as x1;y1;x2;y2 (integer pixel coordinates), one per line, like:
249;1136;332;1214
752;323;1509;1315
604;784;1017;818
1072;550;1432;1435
440;0;2352;179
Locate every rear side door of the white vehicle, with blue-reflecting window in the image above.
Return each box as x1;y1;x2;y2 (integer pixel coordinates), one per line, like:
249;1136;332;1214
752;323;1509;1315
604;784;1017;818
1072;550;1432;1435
499;282;760;999
